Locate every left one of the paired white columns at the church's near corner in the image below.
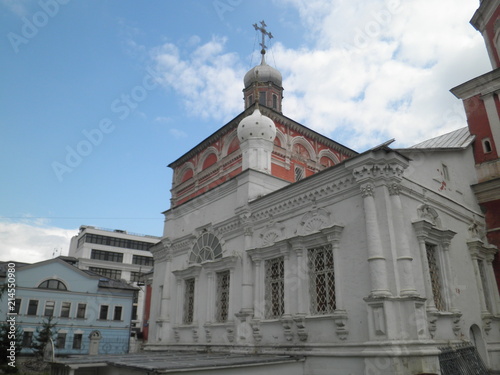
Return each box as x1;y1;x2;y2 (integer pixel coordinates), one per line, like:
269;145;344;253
361;184;391;297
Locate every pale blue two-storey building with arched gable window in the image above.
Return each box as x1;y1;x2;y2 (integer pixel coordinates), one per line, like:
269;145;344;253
0;257;137;355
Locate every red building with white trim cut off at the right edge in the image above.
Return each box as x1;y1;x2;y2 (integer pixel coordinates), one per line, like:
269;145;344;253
451;0;500;286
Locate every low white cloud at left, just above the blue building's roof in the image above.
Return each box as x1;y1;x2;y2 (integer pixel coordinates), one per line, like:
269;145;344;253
0;220;78;263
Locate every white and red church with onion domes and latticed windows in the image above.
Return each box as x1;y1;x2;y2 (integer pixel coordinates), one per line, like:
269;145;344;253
141;18;500;375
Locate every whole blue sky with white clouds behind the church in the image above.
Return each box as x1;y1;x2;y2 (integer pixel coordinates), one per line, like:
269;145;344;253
0;0;490;262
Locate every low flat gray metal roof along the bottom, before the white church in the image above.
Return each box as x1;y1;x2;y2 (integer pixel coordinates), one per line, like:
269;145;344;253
55;351;302;373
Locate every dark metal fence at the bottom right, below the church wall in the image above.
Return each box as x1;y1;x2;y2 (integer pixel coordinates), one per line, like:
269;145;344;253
439;344;490;375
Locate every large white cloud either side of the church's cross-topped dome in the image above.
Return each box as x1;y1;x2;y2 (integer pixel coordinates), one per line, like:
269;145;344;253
153;0;490;150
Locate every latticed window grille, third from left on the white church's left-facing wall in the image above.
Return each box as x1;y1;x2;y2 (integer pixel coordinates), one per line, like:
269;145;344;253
265;257;285;319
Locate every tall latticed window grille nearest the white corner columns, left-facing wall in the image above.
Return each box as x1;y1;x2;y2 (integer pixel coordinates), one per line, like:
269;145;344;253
308;244;335;315
